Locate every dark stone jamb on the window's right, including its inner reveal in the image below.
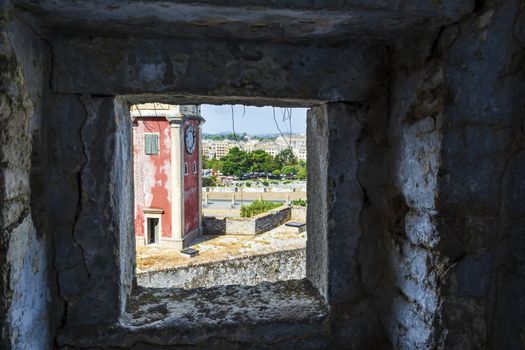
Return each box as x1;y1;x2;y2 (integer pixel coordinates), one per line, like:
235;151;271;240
306;98;389;349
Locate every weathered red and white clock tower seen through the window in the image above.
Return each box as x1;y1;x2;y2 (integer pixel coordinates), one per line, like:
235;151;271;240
131;103;204;249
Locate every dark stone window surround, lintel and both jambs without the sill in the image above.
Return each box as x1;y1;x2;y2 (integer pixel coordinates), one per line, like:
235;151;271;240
43;26;388;342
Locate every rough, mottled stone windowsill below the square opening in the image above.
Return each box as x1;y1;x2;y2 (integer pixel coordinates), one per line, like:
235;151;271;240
58;280;328;348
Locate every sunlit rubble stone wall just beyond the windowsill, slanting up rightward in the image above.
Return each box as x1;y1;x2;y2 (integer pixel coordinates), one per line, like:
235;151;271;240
137;248;306;289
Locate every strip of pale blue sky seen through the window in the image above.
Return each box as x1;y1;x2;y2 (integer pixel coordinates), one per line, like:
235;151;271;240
201;105;307;135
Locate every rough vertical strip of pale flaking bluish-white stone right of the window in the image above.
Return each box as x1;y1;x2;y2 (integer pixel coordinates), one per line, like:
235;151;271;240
381;60;446;349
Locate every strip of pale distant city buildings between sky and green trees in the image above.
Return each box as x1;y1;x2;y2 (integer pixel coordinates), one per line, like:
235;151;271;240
202;135;306;160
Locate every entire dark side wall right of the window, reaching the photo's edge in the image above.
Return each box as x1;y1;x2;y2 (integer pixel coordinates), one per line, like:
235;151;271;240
384;1;525;349
